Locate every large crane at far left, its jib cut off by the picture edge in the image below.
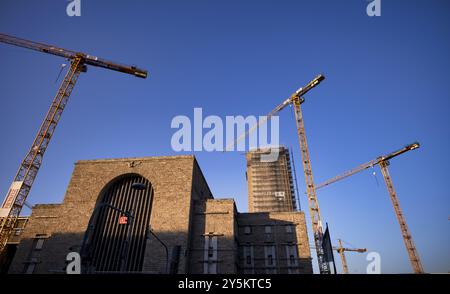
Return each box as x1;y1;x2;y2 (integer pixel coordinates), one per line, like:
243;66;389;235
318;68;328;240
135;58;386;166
0;34;147;253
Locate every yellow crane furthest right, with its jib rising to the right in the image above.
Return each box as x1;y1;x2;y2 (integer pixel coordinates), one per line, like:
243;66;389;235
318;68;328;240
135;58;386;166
316;142;424;274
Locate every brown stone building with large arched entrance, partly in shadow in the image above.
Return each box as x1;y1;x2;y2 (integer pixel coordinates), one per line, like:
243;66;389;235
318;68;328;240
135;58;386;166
9;156;312;274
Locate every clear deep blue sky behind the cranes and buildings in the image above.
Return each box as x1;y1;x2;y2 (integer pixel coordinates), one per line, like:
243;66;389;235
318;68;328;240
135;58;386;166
0;0;450;273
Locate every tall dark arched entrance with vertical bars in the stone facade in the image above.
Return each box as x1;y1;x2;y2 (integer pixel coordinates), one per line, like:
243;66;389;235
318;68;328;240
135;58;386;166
81;174;153;273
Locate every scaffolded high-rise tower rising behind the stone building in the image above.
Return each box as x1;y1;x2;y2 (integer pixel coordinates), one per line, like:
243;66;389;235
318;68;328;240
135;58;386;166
246;146;297;212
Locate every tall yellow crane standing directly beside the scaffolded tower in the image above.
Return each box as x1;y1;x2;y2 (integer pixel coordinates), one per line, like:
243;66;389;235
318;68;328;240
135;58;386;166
225;74;331;274
